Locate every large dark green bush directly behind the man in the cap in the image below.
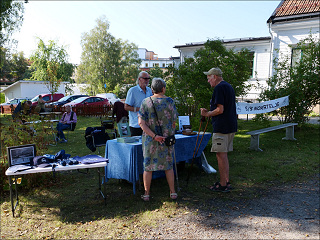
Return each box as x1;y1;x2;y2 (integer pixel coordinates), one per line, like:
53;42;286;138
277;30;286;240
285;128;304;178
166;39;251;125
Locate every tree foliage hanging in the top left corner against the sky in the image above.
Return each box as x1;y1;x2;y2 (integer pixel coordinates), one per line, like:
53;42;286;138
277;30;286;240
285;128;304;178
0;0;28;68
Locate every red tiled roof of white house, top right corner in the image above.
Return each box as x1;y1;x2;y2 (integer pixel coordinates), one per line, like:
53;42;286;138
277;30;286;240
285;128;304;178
267;0;320;23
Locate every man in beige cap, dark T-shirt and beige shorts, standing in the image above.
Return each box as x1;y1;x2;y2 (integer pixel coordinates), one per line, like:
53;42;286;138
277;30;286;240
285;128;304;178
201;68;238;192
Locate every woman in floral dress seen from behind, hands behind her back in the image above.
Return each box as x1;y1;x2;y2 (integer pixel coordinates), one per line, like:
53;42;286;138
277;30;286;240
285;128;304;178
139;78;178;201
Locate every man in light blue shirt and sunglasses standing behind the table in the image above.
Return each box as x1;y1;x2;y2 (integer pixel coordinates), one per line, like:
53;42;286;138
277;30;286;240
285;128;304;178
124;71;152;136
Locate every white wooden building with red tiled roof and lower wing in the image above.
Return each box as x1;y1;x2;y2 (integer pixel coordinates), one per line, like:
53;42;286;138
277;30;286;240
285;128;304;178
174;0;320;101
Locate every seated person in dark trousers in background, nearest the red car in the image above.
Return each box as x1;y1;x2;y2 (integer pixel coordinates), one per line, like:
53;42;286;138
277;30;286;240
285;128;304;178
56;105;77;143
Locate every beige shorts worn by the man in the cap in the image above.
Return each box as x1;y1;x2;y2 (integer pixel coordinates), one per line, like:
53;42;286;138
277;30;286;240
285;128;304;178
211;133;235;152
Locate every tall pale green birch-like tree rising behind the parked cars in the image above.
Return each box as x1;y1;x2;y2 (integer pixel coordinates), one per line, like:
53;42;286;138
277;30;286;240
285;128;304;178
76;16;141;95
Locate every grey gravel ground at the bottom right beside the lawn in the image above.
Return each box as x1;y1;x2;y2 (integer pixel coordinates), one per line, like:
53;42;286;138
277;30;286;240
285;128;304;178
141;174;320;239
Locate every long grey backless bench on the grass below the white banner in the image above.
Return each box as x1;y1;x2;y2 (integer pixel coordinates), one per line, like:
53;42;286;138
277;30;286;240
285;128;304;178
246;123;298;151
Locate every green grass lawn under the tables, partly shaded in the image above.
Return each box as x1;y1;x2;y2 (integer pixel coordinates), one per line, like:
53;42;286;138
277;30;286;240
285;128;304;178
0;116;320;239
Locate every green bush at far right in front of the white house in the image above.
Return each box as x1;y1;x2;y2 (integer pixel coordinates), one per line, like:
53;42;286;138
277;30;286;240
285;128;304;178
260;33;320;124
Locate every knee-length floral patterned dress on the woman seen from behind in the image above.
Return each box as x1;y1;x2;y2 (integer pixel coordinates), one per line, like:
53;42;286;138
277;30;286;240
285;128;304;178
139;97;178;171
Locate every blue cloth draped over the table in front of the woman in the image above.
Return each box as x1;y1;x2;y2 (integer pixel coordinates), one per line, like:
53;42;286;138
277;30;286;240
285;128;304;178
105;132;212;194
